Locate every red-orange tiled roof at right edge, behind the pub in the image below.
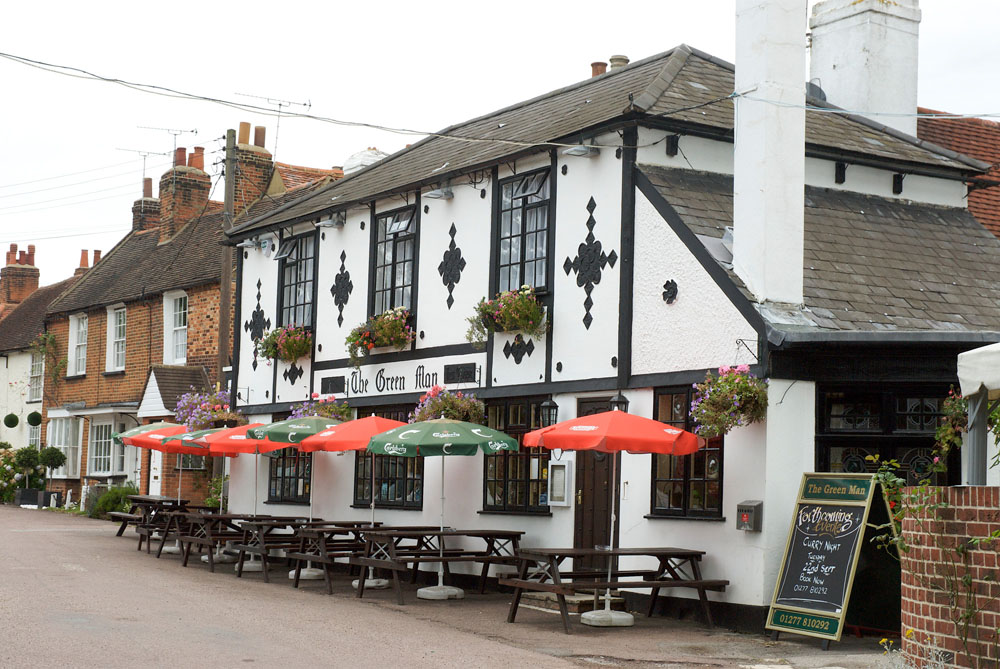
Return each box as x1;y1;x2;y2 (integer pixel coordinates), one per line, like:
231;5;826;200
917;107;1000;236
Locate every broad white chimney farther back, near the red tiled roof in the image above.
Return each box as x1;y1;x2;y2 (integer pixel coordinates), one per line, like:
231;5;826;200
809;0;920;136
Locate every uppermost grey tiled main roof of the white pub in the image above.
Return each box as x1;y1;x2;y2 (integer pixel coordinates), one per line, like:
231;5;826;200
233;45;982;235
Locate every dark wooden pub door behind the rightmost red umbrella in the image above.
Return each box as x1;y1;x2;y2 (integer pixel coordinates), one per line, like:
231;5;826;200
573;398;612;569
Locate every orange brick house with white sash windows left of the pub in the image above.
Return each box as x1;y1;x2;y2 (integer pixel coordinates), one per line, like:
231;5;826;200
42;124;341;500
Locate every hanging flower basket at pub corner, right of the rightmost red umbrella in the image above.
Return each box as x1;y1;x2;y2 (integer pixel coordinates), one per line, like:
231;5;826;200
691;365;767;438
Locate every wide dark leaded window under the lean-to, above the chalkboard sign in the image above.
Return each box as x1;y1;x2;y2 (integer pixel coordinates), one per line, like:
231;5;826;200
816;383;960;485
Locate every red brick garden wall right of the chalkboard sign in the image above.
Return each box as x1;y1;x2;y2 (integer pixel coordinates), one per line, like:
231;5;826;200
901;486;1000;667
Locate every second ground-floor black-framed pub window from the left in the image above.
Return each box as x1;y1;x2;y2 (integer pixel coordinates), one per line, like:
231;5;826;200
354;406;424;509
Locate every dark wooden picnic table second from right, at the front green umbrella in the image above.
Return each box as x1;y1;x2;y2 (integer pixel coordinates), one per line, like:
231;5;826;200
351;528;524;604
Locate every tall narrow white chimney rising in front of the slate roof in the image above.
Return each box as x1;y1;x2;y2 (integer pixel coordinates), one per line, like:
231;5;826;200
733;0;806;304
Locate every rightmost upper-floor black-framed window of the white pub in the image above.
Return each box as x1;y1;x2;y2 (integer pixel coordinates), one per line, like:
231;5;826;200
497;168;549;292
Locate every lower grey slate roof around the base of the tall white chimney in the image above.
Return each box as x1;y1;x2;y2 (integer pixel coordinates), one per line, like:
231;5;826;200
640;165;1000;332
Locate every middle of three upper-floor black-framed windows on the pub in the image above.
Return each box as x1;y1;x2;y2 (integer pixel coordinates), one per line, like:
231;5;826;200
374;207;417;316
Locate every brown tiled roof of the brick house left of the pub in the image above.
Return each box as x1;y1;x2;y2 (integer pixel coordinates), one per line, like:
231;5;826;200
48;166;329;313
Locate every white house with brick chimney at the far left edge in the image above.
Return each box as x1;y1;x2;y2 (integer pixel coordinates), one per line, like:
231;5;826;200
0;244;79;456
